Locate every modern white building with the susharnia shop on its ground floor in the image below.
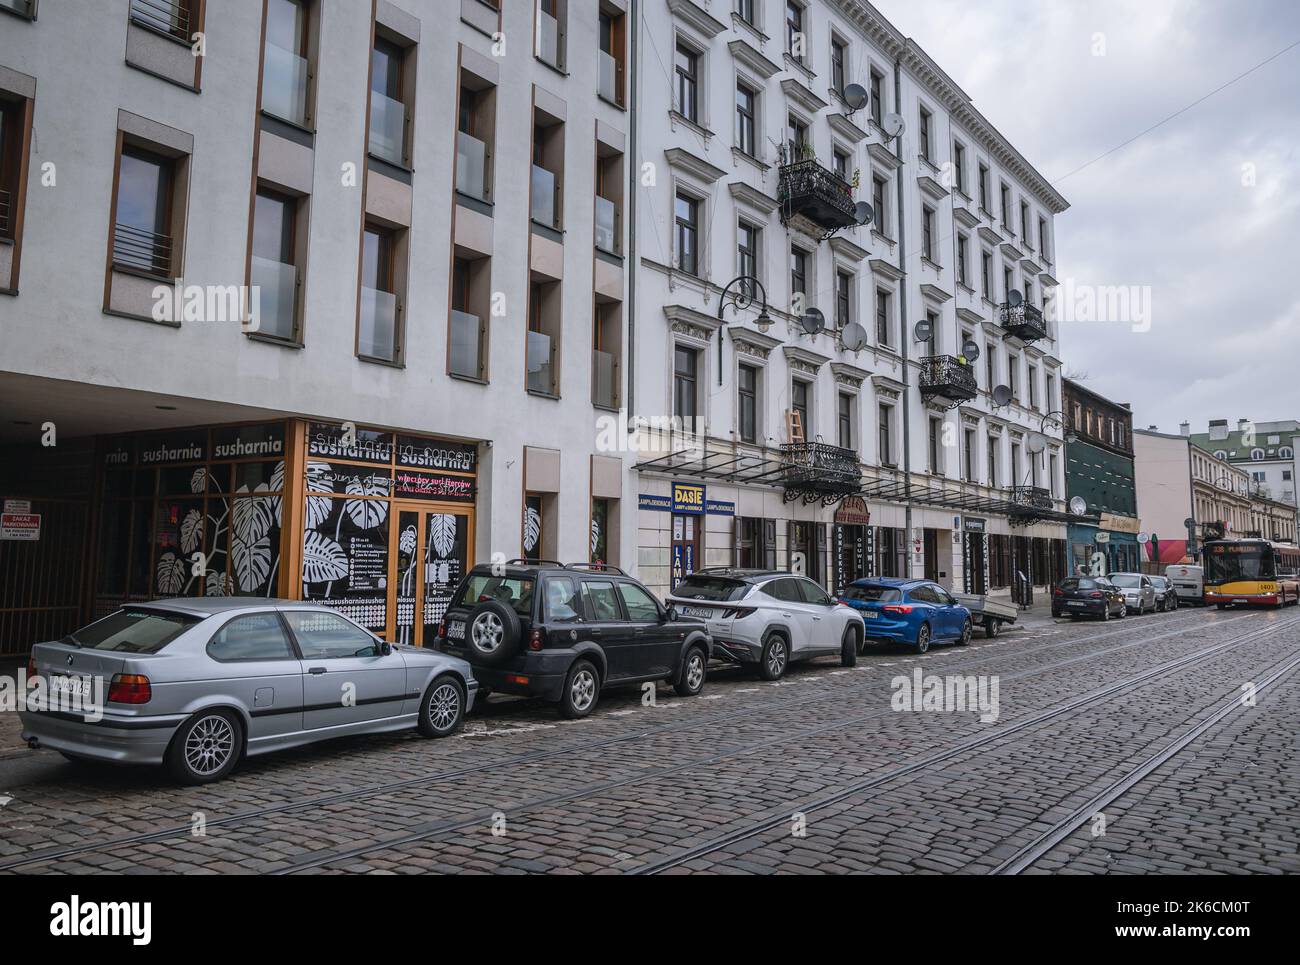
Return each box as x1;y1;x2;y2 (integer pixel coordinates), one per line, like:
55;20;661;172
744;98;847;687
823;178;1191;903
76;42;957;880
0;0;636;650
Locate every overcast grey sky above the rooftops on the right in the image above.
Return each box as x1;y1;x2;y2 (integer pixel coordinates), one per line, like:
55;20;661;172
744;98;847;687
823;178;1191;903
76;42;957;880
874;0;1300;432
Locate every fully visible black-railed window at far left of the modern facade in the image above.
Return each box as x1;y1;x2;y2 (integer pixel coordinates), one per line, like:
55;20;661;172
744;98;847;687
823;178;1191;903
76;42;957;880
113;146;179;278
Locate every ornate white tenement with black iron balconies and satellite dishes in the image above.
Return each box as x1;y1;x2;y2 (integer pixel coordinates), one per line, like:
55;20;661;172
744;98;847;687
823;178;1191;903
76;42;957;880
629;0;1067;592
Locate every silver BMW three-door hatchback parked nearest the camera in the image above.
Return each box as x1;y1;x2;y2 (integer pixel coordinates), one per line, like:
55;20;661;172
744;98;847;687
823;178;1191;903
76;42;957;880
22;597;478;784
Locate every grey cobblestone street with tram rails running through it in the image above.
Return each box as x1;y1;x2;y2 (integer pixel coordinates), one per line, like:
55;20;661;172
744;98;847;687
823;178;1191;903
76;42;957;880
0;609;1300;874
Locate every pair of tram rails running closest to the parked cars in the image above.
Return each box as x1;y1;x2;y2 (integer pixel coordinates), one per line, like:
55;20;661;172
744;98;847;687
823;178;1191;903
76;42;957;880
0;614;1258;873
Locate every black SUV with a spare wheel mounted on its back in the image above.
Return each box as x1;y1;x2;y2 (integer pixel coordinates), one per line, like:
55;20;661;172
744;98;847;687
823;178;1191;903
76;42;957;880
438;559;712;719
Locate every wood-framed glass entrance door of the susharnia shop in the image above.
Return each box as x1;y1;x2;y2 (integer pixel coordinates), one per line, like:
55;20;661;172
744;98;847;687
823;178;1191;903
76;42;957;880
387;502;475;646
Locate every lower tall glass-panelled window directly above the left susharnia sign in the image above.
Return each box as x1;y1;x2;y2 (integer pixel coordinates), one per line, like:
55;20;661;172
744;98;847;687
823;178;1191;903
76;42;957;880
250;187;299;342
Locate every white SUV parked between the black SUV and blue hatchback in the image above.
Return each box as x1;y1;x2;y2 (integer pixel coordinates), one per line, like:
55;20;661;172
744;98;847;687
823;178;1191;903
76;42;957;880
668;570;863;680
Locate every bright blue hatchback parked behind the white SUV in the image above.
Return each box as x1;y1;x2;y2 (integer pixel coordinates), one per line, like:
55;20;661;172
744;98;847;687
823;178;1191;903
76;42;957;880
840;576;971;653
